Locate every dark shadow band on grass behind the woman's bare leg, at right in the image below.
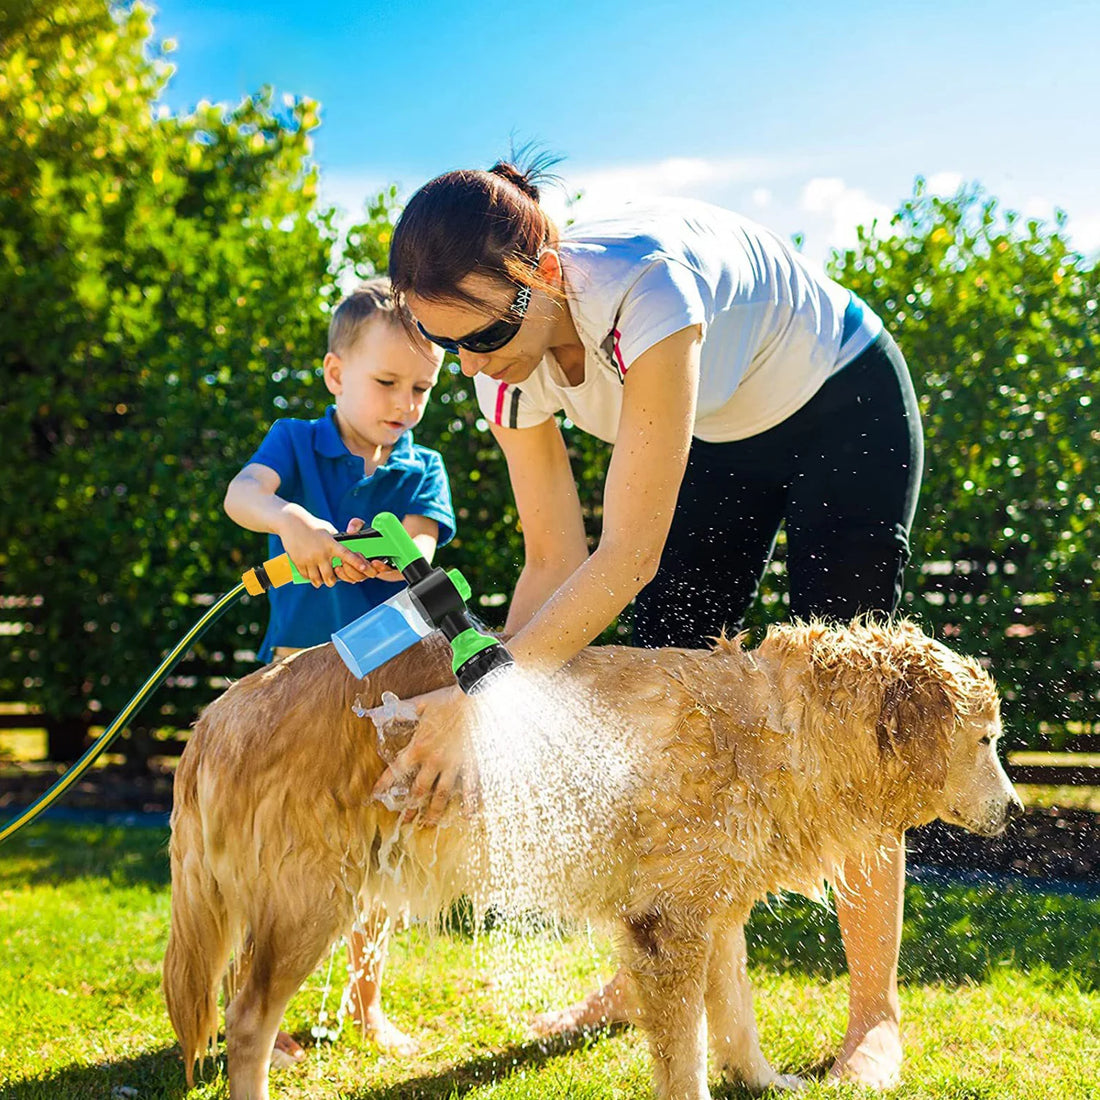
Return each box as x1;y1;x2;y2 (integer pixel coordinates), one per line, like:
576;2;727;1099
748;883;1100;991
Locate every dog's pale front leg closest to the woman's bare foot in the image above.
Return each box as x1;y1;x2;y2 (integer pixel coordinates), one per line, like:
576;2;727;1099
706;919;803;1092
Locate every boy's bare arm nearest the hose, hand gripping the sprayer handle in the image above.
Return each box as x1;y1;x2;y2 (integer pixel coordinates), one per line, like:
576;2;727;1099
224;462;377;589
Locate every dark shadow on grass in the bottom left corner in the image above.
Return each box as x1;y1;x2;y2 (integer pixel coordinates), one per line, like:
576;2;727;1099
0;1044;187;1100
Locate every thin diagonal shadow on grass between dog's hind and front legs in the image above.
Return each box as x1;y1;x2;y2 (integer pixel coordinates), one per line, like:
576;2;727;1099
348;1024;628;1100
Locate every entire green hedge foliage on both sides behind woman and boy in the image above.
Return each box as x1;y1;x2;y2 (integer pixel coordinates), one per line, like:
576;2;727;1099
0;0;1100;754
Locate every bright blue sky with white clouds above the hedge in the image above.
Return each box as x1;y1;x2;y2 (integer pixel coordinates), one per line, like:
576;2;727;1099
156;0;1100;259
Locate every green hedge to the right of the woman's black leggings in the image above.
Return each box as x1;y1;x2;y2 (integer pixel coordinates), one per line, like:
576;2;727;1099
834;180;1100;739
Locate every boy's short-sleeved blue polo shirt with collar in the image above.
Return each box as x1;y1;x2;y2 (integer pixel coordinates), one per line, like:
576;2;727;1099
249;405;454;661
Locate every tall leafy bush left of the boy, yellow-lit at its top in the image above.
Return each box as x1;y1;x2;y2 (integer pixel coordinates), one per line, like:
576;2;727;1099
0;0;343;752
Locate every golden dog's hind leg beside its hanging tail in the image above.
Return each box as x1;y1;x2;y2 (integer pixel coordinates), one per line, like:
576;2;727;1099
226;876;352;1100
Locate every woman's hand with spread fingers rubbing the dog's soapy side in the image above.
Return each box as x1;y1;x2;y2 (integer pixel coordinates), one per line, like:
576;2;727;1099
372;685;477;825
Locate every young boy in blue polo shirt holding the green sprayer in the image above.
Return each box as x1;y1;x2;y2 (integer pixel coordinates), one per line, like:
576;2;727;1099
226;279;454;1066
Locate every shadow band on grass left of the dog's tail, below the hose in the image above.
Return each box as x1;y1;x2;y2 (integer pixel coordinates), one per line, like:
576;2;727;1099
0;822;169;890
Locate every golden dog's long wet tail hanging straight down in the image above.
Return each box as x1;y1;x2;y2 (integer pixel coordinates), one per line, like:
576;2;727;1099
164;738;232;1088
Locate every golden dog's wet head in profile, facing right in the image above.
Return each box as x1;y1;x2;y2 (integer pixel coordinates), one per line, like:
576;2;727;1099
876;624;1023;836
